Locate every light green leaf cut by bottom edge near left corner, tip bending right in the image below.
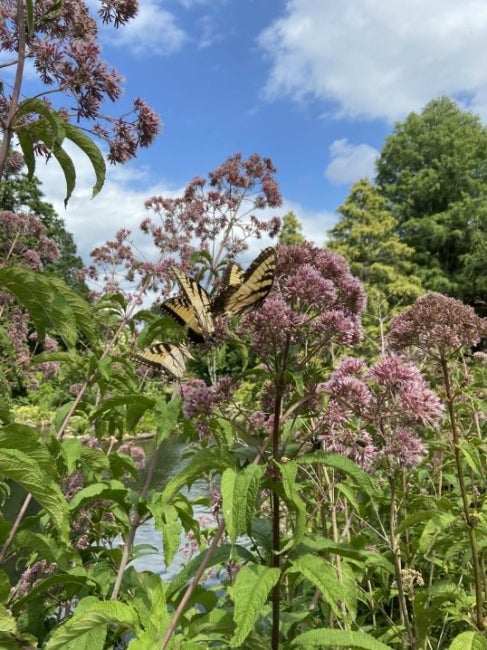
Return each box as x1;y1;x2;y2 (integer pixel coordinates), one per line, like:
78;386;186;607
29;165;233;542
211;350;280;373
47;597;139;650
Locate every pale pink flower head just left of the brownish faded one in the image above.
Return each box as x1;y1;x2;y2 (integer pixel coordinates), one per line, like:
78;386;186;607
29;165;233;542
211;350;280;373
317;355;443;471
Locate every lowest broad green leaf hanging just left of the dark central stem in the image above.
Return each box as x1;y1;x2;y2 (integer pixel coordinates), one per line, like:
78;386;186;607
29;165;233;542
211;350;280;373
230;564;280;648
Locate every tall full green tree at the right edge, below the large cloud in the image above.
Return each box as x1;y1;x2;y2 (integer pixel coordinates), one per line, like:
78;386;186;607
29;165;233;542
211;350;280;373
377;97;487;305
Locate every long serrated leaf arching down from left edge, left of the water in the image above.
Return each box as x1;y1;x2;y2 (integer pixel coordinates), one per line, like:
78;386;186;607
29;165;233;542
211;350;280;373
0;449;69;541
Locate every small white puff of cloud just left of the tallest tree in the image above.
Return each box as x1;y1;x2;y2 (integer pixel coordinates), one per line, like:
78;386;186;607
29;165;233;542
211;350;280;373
325;138;379;185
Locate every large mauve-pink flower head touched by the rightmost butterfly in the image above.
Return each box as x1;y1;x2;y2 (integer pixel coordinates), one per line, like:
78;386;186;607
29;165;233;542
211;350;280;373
241;243;366;365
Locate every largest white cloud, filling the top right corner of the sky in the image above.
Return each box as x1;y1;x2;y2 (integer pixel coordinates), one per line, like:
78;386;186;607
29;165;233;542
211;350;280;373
259;0;487;121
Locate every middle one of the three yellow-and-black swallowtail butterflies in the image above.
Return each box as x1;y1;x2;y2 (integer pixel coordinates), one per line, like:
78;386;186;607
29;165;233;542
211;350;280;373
161;269;215;343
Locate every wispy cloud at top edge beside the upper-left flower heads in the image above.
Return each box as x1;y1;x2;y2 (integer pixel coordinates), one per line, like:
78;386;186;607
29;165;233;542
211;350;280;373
105;0;188;56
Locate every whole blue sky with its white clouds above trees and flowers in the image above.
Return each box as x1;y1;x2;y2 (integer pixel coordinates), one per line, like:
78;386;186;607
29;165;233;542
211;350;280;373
32;0;487;260
